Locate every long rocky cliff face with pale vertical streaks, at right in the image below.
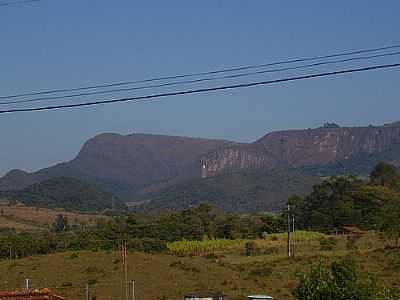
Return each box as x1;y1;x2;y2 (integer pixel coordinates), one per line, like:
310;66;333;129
202;123;400;177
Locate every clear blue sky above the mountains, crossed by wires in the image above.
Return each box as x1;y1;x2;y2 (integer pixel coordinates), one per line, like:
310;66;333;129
0;0;400;175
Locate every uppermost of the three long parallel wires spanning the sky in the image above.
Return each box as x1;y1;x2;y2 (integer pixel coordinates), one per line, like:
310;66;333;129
0;43;400;99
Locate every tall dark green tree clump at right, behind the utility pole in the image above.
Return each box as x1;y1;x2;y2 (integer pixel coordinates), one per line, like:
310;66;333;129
289;162;400;238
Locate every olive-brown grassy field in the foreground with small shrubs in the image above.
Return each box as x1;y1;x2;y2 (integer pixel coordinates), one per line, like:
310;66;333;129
0;233;400;300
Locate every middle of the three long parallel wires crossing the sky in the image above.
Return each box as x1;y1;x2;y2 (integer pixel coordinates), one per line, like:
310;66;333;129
0;52;400;105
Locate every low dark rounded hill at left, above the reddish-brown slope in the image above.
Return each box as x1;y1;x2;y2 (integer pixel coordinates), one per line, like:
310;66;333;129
0;177;124;212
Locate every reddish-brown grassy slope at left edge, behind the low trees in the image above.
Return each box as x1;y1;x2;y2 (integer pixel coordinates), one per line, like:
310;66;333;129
0;204;107;230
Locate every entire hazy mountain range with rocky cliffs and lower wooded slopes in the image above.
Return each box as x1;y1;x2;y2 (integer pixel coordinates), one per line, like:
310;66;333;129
0;122;400;211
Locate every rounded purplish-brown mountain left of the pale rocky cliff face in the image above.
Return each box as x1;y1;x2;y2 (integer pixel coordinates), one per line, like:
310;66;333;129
0;134;233;199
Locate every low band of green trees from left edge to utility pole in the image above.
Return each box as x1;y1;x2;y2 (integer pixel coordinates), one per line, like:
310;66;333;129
0;204;285;258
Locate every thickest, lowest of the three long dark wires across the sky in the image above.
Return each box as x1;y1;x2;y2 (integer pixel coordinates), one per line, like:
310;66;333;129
0;63;400;114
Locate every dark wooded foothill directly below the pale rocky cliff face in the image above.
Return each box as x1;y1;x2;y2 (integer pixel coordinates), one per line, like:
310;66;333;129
136;170;320;212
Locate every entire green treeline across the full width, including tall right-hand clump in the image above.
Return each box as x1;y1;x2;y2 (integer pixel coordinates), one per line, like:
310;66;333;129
0;163;400;258
